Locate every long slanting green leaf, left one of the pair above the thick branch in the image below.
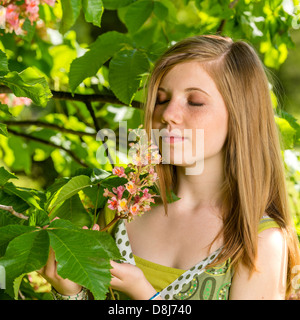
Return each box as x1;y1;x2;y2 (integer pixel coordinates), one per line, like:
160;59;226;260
69;31;128;92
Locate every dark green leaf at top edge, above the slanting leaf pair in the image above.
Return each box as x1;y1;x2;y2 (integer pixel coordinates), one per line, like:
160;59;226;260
124;0;153;33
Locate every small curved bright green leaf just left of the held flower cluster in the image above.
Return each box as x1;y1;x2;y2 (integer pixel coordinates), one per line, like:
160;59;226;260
48;175;91;210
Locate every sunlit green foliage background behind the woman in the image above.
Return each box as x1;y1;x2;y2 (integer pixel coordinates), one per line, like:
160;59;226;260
0;0;300;300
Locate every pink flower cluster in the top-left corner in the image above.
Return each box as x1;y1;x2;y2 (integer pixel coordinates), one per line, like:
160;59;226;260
0;0;55;35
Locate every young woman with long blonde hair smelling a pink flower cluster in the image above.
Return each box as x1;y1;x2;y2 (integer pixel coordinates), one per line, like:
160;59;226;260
41;36;299;300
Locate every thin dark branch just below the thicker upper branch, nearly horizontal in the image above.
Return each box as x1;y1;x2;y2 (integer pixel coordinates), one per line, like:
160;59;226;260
3;120;96;137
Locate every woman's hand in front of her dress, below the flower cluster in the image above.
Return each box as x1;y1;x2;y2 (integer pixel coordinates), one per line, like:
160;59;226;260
110;261;156;300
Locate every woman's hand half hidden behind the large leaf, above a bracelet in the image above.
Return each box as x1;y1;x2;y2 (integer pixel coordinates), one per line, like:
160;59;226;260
38;247;82;296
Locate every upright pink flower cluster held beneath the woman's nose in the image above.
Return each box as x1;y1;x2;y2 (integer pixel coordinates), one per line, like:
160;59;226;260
103;128;161;221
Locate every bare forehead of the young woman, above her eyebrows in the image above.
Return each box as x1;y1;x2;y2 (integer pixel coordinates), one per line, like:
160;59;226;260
159;61;217;94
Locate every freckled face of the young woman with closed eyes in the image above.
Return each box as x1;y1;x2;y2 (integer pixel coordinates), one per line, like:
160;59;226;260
152;61;228;170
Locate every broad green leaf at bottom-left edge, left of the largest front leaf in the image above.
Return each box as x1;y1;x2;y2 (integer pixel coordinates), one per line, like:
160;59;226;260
0;229;49;296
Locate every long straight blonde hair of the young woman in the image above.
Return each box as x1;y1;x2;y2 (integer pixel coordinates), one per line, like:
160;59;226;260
145;36;300;293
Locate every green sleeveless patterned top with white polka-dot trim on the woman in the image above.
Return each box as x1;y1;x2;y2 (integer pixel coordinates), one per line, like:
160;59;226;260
104;207;279;300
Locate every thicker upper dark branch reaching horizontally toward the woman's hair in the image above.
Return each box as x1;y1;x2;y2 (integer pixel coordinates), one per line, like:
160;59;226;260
0;86;141;108
